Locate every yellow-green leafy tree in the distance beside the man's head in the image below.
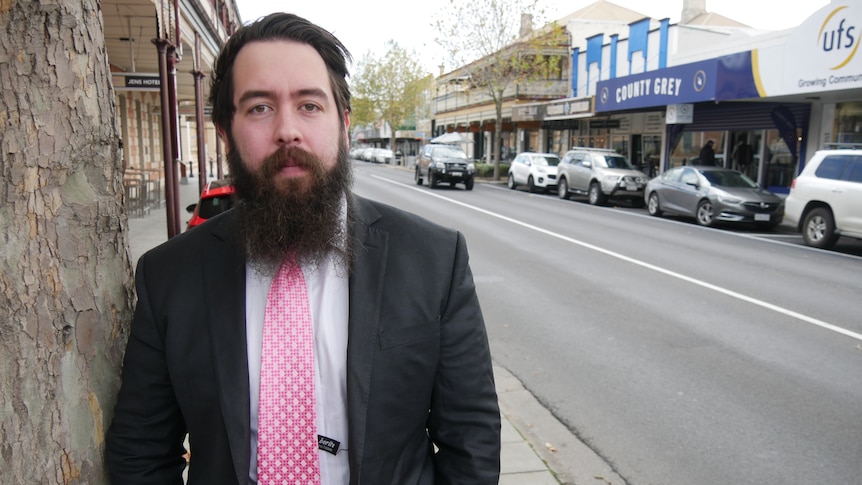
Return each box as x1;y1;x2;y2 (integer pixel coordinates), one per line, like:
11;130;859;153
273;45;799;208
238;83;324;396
351;40;433;160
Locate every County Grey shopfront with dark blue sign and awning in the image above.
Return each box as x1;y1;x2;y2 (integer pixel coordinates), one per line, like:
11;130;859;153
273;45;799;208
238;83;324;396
596;51;811;193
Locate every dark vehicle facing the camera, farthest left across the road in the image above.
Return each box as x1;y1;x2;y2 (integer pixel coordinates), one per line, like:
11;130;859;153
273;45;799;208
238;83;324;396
414;144;476;190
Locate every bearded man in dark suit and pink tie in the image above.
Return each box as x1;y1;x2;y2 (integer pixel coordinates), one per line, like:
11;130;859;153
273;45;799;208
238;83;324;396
106;13;500;485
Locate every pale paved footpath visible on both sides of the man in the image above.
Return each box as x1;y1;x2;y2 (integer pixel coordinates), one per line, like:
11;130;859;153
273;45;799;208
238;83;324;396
129;178;625;485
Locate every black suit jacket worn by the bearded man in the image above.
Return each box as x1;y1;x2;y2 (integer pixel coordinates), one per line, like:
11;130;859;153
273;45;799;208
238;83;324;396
106;196;500;485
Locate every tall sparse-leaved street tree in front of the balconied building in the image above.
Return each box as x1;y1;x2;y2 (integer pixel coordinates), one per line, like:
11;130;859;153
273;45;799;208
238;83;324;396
433;0;569;179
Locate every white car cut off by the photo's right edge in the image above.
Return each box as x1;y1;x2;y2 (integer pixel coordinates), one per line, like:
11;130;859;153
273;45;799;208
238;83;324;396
785;149;862;248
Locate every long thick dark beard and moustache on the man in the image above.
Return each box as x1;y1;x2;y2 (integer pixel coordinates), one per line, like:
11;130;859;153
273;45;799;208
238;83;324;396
227;140;353;274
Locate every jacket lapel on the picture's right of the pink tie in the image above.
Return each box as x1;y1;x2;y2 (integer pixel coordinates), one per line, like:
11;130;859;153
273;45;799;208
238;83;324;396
347;196;389;474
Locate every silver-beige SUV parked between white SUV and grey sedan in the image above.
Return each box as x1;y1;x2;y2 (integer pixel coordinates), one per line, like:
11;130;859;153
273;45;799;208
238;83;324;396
557;147;647;207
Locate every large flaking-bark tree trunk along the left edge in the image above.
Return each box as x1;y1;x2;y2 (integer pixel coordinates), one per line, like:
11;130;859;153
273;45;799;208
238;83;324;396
0;0;134;485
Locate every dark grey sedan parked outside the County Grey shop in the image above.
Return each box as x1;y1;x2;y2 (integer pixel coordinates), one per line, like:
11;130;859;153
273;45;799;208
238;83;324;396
644;166;784;228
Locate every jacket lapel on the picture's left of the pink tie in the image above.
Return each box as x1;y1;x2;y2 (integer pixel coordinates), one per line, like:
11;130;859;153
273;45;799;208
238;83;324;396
201;212;246;483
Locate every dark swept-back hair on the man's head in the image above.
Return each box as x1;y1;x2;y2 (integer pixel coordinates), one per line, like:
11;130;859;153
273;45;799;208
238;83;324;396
209;13;352;133
